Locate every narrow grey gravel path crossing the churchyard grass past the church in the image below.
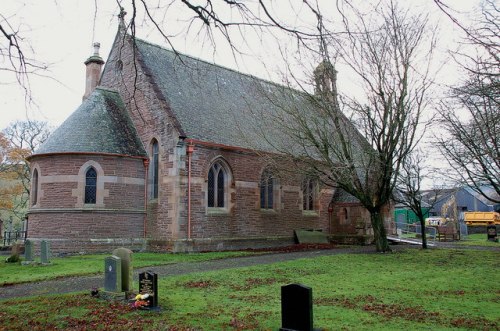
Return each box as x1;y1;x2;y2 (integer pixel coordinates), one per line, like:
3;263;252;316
0;245;500;300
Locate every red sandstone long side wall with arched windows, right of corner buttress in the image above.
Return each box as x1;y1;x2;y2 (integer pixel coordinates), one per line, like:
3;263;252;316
180;146;333;239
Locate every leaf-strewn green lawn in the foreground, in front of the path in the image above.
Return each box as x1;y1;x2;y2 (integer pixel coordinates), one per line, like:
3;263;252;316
0;249;500;330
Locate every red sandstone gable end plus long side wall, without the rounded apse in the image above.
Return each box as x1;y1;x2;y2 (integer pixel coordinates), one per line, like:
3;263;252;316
101;33;332;246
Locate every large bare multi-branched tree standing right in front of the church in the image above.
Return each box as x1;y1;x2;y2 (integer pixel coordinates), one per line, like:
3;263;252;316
263;2;434;252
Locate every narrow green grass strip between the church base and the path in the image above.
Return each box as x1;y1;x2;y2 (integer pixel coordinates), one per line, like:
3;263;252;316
0;252;254;286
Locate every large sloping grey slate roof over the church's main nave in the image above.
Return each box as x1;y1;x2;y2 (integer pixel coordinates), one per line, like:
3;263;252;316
136;39;312;151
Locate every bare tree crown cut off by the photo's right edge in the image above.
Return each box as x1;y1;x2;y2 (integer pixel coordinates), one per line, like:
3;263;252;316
437;0;500;203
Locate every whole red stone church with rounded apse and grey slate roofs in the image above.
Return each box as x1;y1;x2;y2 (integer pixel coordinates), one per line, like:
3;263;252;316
28;24;388;252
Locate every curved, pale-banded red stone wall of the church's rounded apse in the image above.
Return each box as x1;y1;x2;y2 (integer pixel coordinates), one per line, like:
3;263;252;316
28;154;145;252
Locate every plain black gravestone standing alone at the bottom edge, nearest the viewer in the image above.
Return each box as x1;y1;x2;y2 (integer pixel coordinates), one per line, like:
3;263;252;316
280;284;313;331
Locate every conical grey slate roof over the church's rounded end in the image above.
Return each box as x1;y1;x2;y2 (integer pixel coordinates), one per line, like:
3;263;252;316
34;87;147;157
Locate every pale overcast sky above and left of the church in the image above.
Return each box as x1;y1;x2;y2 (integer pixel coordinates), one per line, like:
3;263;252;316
0;0;479;129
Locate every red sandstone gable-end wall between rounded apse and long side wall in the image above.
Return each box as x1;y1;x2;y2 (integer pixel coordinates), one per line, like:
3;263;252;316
100;33;179;240
